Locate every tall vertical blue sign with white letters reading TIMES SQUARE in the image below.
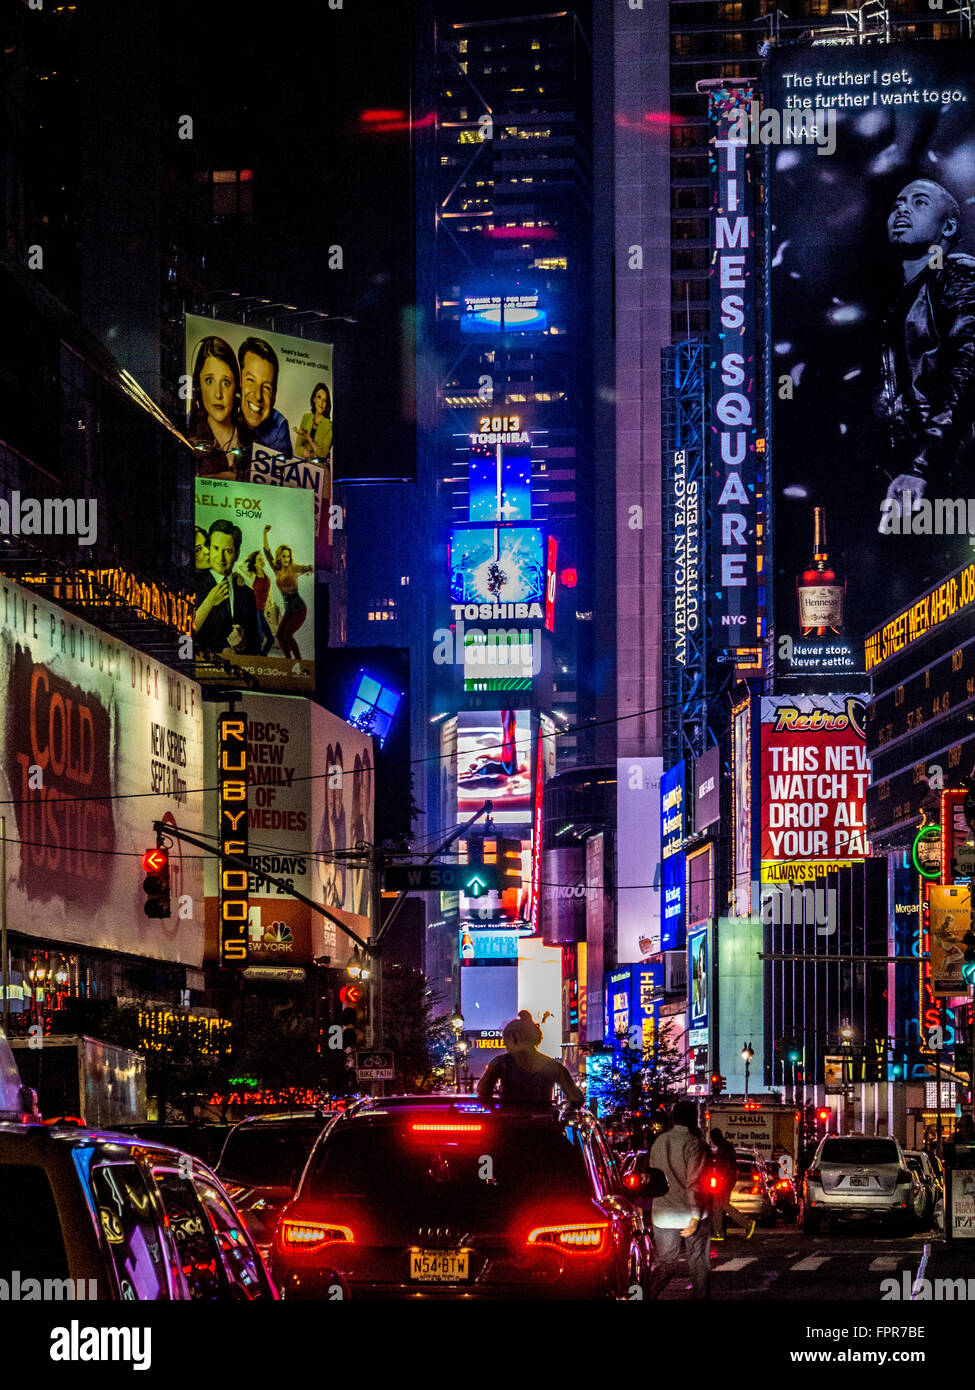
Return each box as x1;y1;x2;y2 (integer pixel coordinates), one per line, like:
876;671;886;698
707;88;765;669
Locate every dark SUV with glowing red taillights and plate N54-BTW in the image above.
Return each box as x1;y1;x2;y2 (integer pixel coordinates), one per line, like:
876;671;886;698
271;1095;652;1300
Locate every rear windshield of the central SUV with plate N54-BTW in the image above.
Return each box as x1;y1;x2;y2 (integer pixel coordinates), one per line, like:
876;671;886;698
310;1122;591;1209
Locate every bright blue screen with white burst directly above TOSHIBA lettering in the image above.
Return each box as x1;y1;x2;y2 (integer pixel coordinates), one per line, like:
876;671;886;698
451;525;545;603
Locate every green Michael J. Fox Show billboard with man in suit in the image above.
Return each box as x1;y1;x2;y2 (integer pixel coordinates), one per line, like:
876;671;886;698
193;478;314;691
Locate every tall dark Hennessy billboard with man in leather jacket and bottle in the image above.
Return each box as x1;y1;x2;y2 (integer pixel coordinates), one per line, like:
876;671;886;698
768;42;975;678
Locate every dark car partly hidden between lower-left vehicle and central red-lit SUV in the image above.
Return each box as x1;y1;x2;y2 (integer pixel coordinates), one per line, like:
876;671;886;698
216;1109;331;1259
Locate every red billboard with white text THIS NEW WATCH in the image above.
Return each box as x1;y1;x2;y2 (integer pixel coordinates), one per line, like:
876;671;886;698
761;695;869;883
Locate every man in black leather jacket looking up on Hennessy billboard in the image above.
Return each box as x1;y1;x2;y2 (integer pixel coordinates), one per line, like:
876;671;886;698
878;178;975;530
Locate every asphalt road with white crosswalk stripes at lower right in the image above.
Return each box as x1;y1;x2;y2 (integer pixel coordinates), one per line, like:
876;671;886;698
661;1225;975;1301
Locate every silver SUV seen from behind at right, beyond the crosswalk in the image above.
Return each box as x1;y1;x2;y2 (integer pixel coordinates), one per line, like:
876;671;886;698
801;1134;919;1234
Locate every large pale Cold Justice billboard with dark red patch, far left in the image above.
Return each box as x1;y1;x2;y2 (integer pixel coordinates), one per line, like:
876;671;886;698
0;580;204;966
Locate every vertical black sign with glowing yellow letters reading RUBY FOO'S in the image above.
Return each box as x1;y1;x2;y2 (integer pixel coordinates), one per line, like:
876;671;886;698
217;714;249;966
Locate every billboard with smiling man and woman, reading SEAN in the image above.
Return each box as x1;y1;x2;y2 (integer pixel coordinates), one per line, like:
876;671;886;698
185;314;334;567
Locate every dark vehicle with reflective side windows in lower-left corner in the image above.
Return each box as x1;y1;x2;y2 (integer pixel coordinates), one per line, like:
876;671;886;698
0;1120;277;1301
